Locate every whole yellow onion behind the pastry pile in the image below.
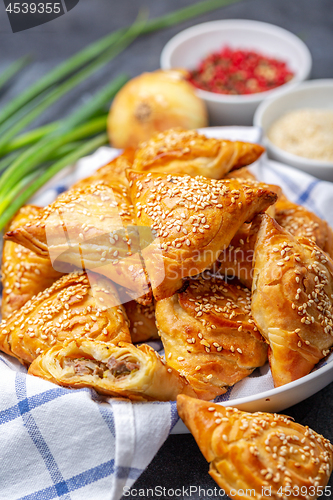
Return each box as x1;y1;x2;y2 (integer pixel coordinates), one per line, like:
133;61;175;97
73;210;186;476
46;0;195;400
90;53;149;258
108;70;207;148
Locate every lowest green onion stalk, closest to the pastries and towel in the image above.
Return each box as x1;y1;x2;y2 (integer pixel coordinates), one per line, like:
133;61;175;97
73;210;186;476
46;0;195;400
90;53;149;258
0;134;108;231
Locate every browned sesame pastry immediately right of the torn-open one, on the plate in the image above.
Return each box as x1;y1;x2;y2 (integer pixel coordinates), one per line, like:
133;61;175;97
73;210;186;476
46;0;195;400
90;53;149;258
156;276;268;400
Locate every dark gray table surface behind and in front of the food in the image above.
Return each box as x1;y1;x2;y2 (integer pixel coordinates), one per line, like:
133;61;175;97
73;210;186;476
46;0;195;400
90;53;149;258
0;0;333;500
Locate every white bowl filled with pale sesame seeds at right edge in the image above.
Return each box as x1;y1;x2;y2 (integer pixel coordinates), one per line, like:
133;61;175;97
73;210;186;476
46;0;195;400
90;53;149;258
254;79;333;181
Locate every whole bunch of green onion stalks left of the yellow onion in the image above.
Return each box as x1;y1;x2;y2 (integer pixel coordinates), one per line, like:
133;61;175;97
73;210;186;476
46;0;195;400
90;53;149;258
0;0;239;225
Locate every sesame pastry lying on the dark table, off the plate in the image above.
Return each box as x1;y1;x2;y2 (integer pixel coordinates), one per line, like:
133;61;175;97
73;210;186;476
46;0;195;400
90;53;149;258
177;395;333;500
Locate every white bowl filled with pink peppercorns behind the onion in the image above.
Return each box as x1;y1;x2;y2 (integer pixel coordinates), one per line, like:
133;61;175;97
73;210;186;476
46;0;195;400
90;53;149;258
161;19;312;125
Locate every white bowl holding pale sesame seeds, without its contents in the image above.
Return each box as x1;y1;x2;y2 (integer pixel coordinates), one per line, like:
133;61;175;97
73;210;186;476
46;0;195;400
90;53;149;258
253;79;333;181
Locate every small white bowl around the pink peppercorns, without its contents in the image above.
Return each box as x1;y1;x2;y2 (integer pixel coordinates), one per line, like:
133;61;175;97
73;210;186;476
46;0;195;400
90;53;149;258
160;19;312;125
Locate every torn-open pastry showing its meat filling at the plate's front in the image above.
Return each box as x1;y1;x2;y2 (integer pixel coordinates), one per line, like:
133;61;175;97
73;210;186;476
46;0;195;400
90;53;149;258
29;339;195;401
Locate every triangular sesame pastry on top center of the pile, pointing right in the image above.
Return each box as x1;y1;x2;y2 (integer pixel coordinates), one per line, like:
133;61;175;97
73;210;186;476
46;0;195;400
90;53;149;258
128;170;277;300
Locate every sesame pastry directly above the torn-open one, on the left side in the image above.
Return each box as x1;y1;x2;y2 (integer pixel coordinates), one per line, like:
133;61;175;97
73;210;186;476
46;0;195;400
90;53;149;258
0;273;131;364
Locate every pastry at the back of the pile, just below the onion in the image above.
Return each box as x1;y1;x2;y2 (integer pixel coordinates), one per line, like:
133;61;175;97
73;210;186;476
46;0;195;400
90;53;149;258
133;129;265;179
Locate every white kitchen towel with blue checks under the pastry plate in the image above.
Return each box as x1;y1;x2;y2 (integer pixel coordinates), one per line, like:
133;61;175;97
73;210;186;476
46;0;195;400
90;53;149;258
0;127;333;500
